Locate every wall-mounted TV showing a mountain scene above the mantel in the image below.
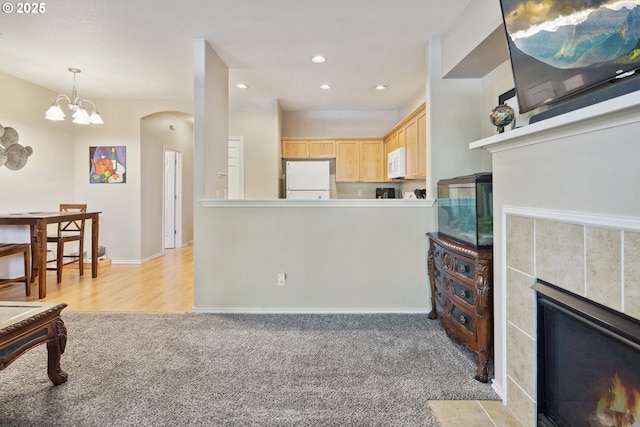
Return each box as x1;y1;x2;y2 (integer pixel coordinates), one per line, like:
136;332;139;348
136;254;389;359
501;0;640;113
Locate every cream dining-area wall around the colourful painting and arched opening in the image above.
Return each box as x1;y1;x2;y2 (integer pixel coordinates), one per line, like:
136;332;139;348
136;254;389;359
0;73;193;263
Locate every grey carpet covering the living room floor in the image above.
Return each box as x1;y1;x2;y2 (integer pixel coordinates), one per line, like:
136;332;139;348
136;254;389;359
0;311;498;427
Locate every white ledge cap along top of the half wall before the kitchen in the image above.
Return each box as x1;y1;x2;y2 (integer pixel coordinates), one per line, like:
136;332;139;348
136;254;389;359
198;199;435;208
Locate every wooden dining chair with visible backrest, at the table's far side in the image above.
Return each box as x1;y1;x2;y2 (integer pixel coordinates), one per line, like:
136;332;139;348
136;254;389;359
47;203;87;283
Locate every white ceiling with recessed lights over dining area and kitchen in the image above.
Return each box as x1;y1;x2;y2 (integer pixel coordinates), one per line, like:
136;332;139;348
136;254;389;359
0;0;470;111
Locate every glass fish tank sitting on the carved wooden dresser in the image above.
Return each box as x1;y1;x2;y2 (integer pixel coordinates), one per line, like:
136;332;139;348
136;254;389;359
438;173;493;249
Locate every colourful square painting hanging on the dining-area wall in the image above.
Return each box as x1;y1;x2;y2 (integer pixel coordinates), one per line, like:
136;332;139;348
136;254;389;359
89;146;127;184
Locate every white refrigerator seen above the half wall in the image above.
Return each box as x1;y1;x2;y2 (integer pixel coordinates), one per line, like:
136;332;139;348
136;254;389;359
285;160;330;199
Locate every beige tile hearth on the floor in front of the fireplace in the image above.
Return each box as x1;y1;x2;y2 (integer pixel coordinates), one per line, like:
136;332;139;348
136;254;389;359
429;400;522;427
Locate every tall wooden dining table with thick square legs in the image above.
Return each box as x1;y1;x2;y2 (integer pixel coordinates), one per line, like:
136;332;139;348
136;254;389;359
0;212;101;299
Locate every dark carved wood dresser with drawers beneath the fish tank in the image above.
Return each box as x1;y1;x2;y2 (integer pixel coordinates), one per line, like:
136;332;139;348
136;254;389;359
427;233;493;382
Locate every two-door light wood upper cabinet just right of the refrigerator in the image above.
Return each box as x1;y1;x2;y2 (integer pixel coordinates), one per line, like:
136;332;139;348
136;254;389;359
336;139;384;182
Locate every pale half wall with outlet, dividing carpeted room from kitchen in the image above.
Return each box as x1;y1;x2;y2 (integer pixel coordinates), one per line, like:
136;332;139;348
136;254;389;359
195;200;434;313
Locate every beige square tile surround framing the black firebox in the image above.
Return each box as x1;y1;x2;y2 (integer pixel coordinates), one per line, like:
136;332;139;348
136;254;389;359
503;212;640;426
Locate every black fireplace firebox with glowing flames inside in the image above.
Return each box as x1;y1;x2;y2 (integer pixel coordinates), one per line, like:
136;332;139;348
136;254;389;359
533;280;640;427
